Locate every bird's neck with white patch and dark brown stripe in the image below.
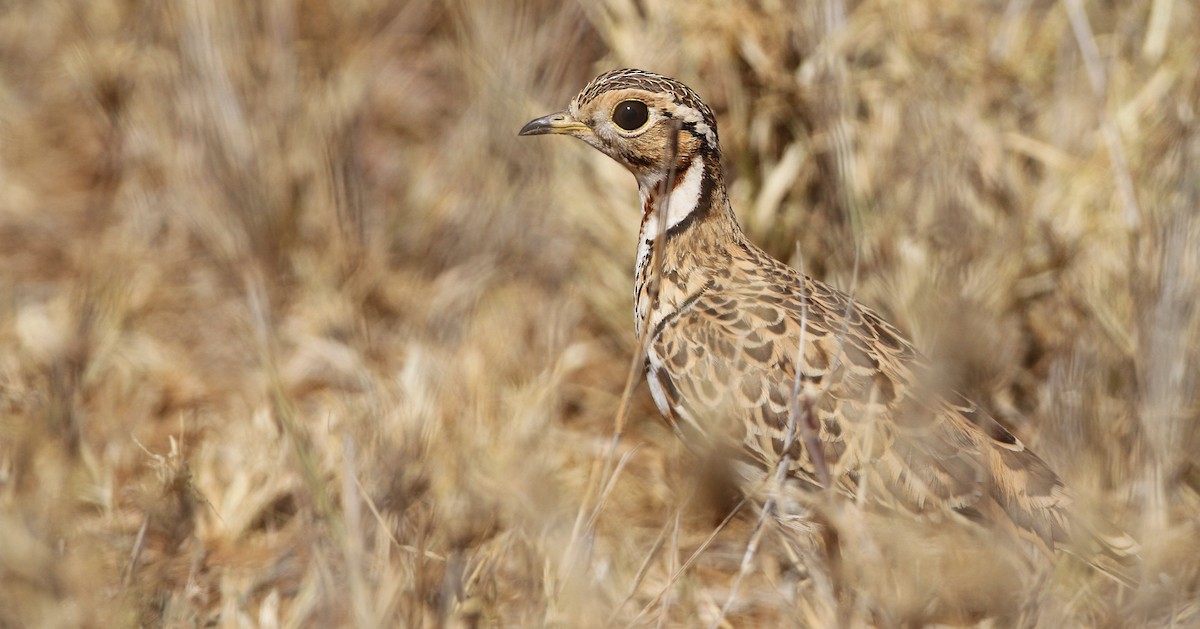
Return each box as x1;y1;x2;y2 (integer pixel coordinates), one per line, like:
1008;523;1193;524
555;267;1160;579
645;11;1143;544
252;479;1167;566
635;154;745;335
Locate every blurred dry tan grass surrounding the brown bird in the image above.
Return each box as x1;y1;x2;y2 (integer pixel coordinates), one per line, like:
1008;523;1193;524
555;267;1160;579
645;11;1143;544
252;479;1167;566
0;0;1200;627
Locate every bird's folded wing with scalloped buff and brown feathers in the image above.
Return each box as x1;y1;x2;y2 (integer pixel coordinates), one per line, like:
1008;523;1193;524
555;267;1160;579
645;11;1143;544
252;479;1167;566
649;265;1069;551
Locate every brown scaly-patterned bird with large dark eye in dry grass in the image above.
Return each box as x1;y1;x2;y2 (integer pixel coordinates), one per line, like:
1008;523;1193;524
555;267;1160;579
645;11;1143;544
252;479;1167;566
518;68;1129;609
